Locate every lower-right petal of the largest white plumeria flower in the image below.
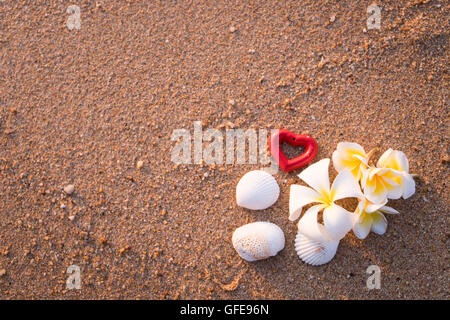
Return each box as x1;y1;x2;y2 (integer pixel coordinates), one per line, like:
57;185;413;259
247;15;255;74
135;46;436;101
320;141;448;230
323;204;353;240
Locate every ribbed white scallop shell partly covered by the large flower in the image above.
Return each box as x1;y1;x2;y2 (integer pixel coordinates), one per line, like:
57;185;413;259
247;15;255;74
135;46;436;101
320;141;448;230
295;232;339;266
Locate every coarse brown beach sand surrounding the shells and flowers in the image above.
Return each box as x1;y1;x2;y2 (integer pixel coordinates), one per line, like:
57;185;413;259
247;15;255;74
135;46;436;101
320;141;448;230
0;0;449;299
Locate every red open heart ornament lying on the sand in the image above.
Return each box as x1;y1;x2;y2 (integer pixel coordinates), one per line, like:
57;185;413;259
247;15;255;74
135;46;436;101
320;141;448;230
267;129;318;172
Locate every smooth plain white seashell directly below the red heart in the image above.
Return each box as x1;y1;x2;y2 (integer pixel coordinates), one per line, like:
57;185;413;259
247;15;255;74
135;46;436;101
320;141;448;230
236;170;280;210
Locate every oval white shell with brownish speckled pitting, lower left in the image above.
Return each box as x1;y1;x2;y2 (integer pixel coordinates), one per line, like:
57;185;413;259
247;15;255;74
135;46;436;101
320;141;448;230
232;221;285;261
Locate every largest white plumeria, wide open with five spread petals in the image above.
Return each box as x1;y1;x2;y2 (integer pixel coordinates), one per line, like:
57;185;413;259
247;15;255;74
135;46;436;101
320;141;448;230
289;158;362;241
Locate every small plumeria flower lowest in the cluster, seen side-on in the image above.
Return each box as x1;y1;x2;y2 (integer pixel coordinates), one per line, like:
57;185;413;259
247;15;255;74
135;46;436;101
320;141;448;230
353;198;399;239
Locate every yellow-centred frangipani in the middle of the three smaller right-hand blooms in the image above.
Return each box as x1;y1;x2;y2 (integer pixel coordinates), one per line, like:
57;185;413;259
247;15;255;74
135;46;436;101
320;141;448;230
361;167;403;203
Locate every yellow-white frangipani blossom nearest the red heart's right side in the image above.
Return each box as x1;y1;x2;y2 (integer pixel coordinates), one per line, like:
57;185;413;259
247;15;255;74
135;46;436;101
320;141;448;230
332;142;369;181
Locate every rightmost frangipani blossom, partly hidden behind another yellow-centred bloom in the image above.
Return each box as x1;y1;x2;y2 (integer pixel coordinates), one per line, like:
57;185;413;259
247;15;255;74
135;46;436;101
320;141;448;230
377;148;416;199
